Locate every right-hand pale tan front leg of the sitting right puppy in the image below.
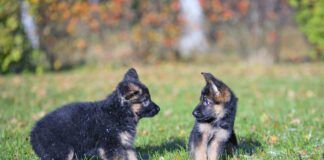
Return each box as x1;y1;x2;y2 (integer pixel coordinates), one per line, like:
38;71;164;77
207;128;231;160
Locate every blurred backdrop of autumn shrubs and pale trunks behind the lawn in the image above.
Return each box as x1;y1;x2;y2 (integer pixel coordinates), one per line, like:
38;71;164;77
0;0;324;73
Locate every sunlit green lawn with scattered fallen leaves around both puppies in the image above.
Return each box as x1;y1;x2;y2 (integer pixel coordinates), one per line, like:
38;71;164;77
0;63;324;160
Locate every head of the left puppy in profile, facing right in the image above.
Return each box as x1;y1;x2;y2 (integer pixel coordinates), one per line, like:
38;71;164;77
117;68;160;118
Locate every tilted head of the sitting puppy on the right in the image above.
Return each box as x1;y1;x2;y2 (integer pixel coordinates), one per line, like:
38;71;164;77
192;73;237;122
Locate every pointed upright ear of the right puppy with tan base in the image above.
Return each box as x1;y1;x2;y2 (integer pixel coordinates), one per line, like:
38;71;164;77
201;72;231;102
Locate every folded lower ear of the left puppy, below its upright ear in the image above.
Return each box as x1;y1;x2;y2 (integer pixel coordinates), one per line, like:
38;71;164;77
117;82;142;100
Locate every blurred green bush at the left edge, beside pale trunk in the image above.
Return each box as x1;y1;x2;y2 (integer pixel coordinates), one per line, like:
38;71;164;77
0;0;42;73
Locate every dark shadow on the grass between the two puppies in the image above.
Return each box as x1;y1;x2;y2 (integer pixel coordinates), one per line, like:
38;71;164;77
136;138;186;160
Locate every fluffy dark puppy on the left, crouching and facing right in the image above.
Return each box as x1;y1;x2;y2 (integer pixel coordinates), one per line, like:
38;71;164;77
30;68;160;160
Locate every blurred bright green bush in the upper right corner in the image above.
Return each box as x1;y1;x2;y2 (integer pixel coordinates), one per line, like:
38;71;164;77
290;0;324;59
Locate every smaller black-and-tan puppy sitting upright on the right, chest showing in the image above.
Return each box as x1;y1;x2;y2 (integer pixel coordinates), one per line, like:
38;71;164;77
189;73;238;160
